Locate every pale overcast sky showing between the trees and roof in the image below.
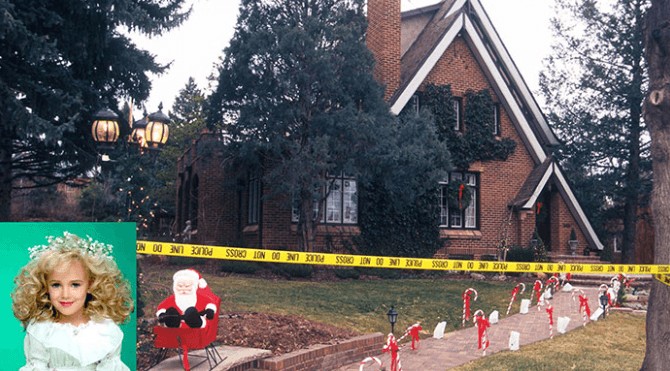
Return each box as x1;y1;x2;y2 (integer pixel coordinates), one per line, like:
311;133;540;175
134;0;553;112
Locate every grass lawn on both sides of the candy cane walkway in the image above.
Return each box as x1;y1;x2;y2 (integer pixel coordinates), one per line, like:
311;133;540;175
141;265;645;370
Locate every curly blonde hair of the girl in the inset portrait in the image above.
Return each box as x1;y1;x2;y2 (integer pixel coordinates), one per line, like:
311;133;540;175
12;240;134;328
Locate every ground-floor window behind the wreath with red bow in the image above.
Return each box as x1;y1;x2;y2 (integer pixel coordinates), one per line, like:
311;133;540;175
439;172;479;229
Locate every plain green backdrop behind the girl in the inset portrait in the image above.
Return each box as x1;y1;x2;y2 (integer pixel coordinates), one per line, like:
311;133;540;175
0;223;137;370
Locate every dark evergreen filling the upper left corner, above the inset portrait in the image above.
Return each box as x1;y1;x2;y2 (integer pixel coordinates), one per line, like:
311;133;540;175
0;0;189;220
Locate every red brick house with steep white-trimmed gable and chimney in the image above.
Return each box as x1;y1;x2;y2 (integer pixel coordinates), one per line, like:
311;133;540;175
177;0;603;257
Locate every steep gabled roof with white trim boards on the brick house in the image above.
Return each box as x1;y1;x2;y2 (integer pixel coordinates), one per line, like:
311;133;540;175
389;0;603;250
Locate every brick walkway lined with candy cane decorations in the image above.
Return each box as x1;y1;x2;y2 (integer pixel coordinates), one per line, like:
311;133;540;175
338;286;598;371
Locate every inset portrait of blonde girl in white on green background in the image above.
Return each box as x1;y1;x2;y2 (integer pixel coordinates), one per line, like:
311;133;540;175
0;222;137;371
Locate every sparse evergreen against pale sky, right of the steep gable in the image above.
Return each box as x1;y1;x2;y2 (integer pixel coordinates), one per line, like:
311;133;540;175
540;0;650;263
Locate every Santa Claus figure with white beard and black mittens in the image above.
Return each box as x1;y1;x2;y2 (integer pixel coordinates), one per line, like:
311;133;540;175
156;269;217;328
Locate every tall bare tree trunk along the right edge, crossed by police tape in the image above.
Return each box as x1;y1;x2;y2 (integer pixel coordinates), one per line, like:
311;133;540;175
642;0;670;370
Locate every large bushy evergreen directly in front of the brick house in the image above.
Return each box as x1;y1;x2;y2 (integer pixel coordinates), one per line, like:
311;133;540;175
209;0;410;251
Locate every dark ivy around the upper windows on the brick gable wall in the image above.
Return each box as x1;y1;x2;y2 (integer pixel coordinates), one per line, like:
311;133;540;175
419;84;516;170
